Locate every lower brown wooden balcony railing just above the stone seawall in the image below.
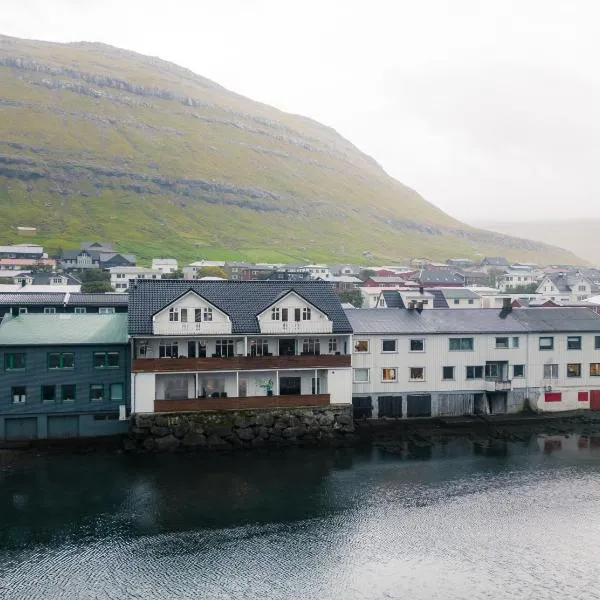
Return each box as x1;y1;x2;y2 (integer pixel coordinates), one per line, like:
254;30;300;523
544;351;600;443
154;394;329;412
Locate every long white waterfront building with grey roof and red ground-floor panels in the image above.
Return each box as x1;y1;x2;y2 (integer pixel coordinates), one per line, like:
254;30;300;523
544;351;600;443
346;307;600;418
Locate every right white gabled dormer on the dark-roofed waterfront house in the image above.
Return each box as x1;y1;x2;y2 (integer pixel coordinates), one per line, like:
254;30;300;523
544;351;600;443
257;290;333;333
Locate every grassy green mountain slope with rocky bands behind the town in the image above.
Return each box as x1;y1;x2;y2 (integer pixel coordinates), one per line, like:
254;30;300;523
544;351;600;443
0;36;578;263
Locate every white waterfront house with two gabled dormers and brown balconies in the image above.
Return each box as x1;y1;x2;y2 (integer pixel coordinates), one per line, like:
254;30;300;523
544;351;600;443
129;280;352;413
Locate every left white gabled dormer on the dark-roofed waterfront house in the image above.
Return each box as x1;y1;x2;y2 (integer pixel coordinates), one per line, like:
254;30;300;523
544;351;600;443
152;290;231;335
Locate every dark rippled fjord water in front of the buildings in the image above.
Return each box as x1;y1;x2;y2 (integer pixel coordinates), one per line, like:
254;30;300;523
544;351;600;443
0;436;600;600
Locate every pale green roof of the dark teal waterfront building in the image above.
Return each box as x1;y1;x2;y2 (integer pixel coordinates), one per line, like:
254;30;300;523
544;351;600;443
0;313;127;346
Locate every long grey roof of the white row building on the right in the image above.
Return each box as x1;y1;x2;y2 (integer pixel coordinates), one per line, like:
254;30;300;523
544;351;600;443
346;307;600;335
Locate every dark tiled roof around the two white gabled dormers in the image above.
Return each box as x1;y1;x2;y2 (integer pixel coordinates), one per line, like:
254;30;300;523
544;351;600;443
129;279;352;335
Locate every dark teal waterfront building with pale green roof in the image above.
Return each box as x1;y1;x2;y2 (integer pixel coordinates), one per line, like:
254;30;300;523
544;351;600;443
0;313;130;440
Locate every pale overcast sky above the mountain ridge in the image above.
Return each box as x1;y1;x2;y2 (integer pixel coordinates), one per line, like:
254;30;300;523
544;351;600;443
0;0;600;222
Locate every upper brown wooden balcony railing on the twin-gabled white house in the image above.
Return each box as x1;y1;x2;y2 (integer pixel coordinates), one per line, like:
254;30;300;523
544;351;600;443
131;354;351;373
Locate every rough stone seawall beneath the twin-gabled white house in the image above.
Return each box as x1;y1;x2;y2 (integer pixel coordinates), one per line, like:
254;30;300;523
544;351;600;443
125;404;354;452
